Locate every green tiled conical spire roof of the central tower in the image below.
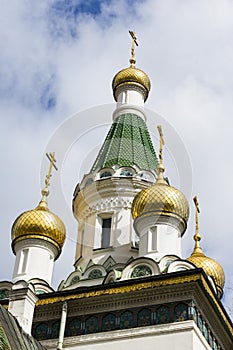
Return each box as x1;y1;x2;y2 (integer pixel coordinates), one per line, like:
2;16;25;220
91;113;158;171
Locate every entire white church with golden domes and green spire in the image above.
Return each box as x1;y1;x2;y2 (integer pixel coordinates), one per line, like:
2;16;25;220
0;31;233;350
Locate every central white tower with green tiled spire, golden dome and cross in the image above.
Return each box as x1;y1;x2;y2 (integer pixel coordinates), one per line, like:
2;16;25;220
68;32;158;284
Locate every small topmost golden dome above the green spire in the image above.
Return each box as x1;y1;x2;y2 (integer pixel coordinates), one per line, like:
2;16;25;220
112;64;150;101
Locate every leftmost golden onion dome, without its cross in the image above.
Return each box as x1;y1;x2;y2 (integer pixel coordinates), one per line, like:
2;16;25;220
11;201;66;257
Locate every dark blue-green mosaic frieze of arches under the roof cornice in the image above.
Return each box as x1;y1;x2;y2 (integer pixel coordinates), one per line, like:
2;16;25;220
32;302;221;350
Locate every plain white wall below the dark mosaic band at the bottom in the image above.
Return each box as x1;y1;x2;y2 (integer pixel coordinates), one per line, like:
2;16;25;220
42;321;212;350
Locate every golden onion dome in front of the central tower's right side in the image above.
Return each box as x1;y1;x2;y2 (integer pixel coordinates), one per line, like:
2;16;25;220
131;164;189;232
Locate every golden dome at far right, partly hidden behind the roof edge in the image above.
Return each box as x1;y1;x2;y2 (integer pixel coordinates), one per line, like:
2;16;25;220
186;252;225;293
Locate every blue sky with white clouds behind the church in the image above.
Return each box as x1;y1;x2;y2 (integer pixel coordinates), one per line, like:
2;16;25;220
0;0;233;314
